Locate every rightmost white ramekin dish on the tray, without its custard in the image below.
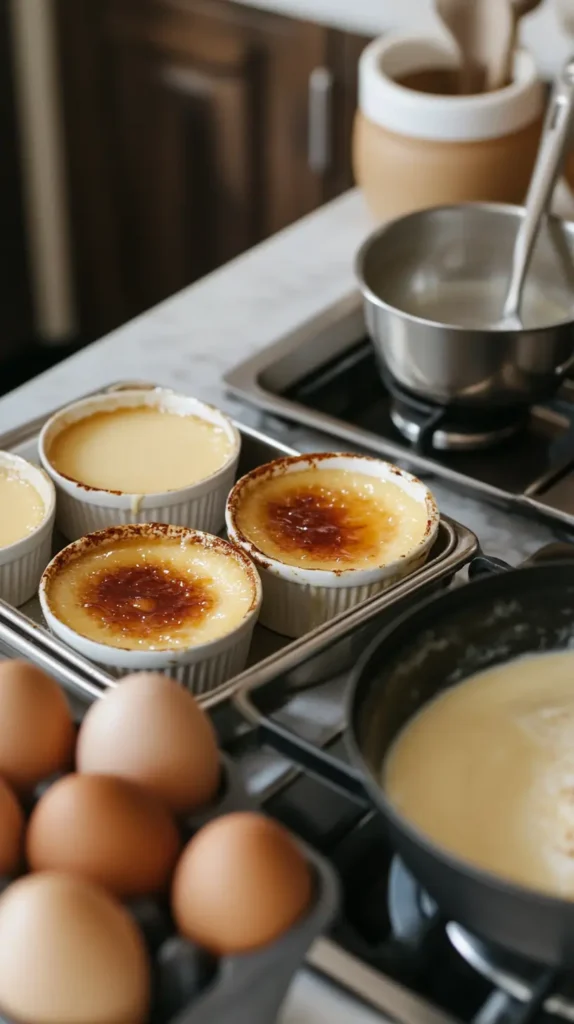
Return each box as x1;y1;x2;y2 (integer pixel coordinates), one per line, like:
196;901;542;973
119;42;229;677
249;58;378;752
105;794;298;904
225;452;440;637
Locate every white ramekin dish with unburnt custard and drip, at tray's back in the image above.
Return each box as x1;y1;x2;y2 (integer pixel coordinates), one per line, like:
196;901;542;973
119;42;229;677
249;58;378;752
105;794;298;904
39;388;241;541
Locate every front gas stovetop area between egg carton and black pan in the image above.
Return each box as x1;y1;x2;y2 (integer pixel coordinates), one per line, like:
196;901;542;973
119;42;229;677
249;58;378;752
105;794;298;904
217;544;574;1024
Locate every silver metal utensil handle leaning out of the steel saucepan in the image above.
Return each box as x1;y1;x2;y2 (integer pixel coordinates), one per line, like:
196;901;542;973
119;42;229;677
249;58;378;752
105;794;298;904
504;57;574;316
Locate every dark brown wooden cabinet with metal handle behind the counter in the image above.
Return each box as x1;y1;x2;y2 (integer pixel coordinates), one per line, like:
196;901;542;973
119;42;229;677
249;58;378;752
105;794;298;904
57;0;365;333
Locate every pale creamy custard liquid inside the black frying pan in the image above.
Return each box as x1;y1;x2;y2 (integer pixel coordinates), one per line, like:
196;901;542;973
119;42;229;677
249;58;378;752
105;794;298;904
383;651;574;899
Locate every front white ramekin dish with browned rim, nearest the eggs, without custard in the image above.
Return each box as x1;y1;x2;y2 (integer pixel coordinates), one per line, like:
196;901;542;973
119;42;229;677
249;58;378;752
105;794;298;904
39;523;262;696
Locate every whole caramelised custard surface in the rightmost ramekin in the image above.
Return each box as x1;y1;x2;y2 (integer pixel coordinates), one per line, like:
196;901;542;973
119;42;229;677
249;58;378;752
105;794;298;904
235;468;428;571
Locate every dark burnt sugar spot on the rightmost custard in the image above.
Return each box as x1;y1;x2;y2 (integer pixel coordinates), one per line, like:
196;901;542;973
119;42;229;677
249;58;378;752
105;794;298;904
265;485;397;562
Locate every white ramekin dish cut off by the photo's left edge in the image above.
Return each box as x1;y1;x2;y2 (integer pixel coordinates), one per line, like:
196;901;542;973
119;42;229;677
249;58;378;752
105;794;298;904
0;452;56;607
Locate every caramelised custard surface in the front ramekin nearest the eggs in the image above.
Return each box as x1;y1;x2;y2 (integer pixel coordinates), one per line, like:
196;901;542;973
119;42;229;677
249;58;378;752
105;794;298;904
46;539;254;650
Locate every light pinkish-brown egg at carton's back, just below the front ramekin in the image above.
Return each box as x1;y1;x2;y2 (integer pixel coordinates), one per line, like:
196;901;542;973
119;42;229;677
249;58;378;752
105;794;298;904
77;672;221;814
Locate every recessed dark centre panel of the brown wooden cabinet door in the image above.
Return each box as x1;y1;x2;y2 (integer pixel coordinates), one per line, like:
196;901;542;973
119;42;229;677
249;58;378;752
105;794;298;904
103;4;259;310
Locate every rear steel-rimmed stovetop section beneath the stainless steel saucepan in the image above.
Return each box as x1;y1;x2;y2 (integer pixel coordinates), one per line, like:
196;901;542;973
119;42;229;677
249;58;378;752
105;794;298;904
225;297;574;528
